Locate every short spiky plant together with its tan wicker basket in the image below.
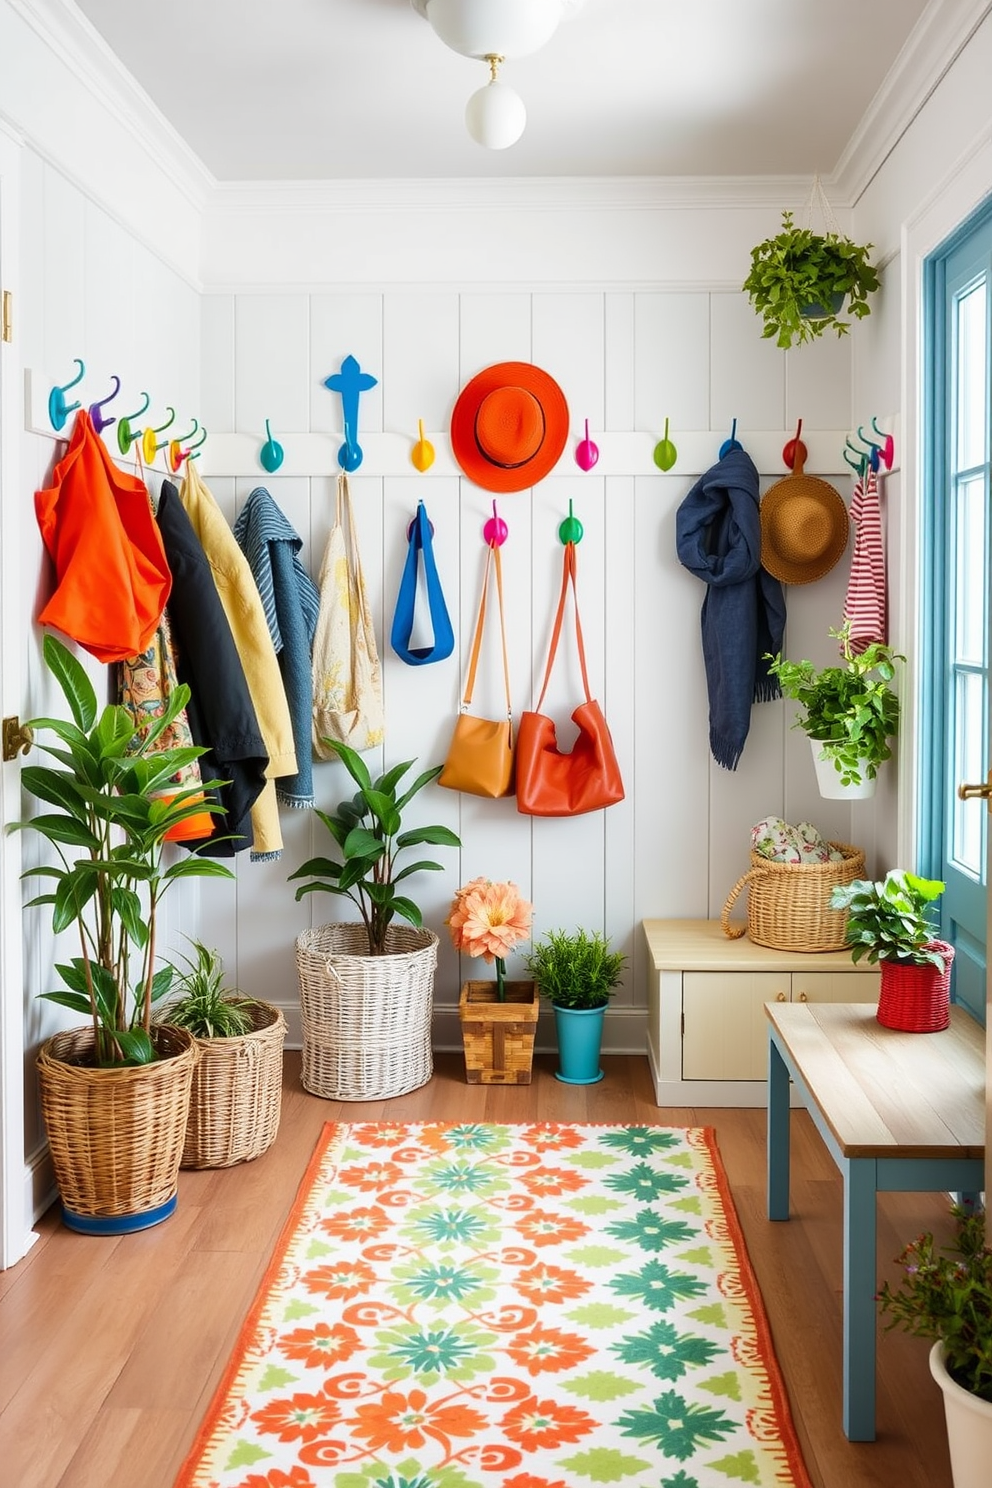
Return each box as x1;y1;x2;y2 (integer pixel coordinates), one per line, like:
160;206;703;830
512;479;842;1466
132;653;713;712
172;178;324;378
161;940;286;1168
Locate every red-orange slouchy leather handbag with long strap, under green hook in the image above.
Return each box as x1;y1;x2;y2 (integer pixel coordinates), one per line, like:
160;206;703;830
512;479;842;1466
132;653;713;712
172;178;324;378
516;543;623;817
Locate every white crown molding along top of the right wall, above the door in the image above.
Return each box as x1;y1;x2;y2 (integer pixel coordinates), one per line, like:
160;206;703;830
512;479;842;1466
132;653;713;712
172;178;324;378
830;0;992;207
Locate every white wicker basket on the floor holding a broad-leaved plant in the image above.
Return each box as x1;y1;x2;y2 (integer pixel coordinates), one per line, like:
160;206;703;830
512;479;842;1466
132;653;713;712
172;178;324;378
296;924;437;1101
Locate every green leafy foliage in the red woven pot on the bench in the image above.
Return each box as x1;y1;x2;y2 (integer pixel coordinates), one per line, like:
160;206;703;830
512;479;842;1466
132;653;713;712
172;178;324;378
830;868;944;972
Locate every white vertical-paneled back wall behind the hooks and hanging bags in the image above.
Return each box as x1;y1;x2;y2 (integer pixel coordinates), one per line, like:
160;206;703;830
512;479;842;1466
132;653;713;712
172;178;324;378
193;286;870;1049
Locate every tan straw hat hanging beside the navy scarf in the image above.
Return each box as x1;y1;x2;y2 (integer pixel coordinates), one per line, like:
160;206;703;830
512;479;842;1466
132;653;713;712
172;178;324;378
759;464;851;583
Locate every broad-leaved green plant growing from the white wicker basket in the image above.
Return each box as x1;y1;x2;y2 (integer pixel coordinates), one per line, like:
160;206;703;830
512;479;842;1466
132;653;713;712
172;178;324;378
290;740;461;955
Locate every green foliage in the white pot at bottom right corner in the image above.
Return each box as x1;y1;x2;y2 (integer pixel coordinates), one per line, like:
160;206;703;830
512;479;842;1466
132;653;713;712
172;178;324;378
879;1205;992;1402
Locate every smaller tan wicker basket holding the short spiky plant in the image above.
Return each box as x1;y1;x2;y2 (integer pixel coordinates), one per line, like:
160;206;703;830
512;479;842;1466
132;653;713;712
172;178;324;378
181;998;286;1168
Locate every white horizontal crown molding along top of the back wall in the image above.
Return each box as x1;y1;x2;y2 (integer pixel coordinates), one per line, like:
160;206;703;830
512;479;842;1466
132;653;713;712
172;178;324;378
208;176;826;216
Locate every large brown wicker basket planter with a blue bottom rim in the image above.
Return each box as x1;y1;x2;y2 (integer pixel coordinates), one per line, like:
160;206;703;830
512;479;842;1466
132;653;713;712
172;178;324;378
37;1024;199;1235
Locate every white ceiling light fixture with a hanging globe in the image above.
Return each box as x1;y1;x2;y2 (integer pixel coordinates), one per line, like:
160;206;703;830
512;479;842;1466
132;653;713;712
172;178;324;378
410;0;582;150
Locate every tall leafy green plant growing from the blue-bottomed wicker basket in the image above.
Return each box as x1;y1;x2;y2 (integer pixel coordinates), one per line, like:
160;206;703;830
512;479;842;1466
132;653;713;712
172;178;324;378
15;635;232;1065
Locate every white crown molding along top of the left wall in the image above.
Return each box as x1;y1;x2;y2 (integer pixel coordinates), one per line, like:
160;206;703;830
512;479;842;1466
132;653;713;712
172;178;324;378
6;0;216;211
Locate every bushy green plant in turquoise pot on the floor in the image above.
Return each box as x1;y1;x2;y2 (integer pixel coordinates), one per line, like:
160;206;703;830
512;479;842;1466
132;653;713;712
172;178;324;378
526;930;626;1085
